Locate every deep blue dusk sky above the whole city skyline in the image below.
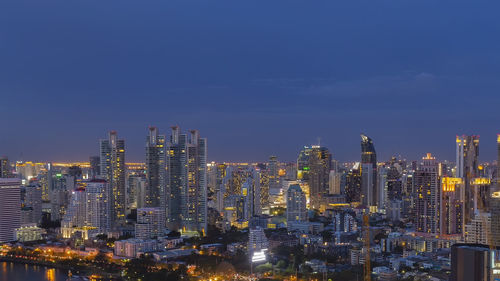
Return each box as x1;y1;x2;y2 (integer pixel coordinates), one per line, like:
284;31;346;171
0;0;500;161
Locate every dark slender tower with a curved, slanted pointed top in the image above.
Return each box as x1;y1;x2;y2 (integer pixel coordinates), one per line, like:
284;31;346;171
361;134;377;207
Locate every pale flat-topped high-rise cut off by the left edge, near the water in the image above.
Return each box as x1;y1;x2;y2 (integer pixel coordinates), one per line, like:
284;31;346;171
0;178;21;243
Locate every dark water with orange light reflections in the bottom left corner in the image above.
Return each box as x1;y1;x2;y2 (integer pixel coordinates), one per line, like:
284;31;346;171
0;262;67;281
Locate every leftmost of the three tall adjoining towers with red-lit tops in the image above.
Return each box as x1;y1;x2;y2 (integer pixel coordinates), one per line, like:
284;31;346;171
146;124;167;212
